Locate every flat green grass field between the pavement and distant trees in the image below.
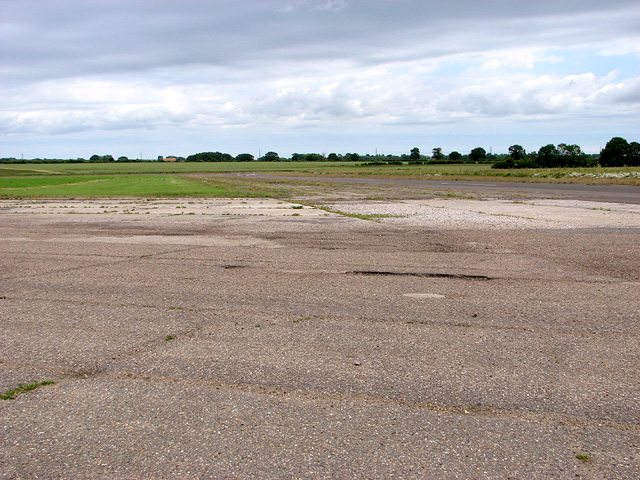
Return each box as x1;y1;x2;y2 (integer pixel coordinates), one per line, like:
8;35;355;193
0;162;640;198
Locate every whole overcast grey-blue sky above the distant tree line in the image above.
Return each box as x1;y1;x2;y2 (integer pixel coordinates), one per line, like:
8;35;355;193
0;0;640;158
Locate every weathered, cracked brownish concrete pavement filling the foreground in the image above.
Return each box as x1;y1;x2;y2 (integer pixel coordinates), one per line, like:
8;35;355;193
0;199;640;479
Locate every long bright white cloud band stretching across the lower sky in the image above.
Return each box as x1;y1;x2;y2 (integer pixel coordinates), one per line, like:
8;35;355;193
1;54;640;141
